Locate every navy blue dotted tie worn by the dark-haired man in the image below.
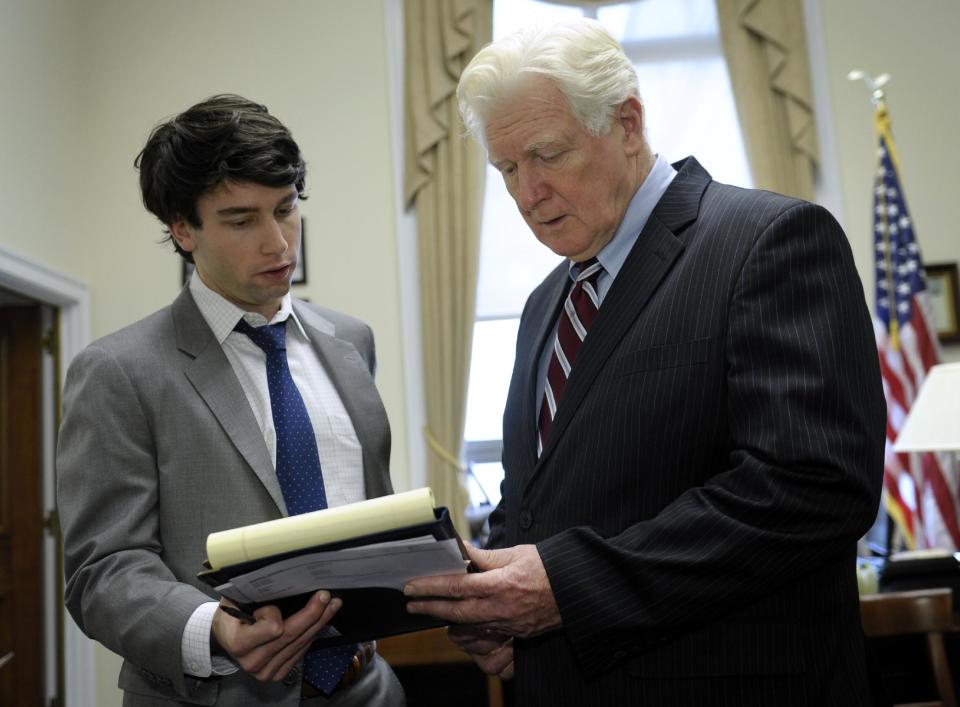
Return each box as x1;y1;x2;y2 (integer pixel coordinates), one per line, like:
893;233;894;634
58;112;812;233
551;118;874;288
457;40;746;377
234;319;357;695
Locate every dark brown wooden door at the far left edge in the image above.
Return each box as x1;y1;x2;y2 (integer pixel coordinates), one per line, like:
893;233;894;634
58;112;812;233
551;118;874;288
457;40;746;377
0;305;44;707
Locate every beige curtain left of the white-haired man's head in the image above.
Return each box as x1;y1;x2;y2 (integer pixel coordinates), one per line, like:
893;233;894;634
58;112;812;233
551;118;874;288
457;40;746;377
404;0;493;533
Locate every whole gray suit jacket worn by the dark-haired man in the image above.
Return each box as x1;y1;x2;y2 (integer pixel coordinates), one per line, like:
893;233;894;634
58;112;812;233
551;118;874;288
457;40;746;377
57;288;392;707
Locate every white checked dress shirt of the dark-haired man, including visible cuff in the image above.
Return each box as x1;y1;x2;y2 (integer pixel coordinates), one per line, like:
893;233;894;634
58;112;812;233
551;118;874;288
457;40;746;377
181;272;366;677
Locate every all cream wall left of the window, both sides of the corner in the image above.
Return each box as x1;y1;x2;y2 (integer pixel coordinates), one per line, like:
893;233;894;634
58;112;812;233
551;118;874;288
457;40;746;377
0;0;409;707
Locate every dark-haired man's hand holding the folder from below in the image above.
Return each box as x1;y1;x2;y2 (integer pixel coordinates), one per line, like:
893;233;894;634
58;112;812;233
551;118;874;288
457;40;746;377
213;591;342;681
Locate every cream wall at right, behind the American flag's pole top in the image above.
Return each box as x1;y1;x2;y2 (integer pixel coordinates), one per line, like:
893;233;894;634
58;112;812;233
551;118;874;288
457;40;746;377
815;0;960;360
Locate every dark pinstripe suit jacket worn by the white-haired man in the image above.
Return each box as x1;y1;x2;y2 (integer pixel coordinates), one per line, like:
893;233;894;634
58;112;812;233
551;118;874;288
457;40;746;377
490;158;885;707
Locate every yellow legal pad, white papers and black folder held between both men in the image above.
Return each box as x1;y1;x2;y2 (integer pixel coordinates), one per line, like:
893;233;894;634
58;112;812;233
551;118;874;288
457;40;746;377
198;488;467;645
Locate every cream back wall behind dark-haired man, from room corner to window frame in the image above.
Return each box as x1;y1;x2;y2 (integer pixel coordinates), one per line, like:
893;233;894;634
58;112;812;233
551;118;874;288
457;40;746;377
69;0;407;442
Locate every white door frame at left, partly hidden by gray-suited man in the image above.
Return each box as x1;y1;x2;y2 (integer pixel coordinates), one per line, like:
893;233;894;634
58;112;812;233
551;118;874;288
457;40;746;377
0;247;96;707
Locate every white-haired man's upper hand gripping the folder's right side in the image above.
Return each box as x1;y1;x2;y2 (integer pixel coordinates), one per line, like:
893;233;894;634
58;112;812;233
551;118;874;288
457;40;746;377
403;545;561;640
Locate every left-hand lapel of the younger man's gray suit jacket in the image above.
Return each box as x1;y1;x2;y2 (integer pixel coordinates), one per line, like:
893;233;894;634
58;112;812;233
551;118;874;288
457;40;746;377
172;288;287;515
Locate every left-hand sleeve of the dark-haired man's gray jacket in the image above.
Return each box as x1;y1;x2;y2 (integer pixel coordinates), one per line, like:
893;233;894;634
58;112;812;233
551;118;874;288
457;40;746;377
57;346;209;695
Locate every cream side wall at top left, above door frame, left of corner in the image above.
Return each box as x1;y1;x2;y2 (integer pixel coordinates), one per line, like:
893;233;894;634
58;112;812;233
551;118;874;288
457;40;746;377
0;0;85;277
